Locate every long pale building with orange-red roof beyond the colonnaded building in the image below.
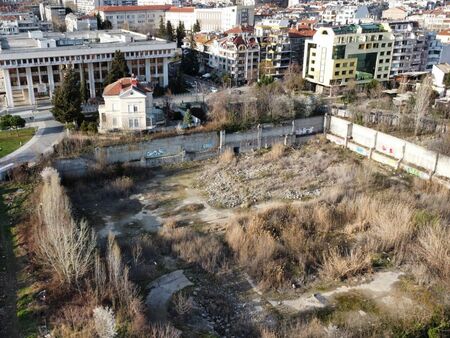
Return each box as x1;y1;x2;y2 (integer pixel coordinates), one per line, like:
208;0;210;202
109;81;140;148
96;5;170;32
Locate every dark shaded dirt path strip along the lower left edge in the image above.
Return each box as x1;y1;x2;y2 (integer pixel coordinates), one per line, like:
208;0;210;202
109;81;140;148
0;188;20;338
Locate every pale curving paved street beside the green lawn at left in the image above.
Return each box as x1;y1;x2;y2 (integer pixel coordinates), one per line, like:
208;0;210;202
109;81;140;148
0;110;64;167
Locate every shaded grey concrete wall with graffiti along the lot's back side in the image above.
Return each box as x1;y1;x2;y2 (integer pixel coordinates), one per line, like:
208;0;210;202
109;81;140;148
55;116;324;177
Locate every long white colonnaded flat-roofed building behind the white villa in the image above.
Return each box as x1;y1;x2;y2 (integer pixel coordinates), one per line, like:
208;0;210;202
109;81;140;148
0;30;176;108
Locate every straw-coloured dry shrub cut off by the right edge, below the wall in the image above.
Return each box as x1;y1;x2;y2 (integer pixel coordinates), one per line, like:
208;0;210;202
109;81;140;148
417;223;450;281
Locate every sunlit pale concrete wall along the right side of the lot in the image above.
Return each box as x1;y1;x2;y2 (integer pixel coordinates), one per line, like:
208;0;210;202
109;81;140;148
324;116;450;187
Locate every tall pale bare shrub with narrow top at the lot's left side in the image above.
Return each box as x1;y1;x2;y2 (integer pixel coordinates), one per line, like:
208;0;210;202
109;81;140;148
36;168;95;286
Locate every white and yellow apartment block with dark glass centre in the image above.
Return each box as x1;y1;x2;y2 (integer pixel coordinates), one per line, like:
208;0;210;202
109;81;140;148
303;23;395;92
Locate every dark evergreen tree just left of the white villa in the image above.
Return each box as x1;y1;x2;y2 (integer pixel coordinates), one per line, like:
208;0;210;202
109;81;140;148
52;68;83;123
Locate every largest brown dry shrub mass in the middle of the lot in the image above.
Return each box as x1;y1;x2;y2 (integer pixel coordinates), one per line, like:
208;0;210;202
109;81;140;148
225;203;345;288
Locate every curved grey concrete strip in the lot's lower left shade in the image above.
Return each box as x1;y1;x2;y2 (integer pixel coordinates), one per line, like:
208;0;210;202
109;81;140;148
145;270;193;321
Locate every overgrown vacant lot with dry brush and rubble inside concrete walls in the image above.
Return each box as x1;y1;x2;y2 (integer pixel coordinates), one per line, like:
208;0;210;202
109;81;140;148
15;137;450;337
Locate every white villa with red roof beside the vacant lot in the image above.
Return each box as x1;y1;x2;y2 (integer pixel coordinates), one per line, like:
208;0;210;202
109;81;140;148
98;77;164;133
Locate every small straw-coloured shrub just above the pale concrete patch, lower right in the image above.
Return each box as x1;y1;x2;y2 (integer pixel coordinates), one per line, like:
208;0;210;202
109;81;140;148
320;248;371;280
